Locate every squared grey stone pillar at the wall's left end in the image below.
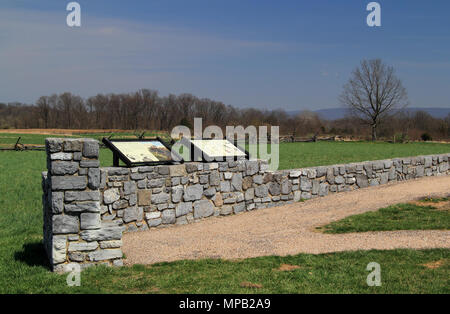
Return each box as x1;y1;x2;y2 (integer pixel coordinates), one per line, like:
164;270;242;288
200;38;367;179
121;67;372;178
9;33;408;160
43;138;123;272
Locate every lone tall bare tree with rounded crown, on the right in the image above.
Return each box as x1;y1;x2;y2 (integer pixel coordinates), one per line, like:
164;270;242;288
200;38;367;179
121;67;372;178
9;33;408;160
340;59;407;141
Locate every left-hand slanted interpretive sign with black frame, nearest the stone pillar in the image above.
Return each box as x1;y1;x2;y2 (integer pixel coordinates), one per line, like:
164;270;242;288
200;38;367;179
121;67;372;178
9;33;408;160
103;137;182;167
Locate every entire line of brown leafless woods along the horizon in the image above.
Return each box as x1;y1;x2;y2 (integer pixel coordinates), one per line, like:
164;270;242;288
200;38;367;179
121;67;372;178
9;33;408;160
0;89;450;140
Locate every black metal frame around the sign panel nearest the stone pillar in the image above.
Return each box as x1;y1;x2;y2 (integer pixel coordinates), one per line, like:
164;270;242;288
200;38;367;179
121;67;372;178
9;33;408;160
102;137;184;167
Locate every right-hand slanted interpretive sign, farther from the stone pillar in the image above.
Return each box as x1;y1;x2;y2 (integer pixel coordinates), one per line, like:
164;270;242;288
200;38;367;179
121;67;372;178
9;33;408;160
181;138;249;161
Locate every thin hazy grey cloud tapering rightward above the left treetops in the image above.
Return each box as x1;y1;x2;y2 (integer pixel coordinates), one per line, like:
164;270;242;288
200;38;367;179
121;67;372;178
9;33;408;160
0;9;290;102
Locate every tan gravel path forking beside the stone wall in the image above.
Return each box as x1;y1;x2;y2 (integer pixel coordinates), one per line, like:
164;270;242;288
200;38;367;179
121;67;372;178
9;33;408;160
123;176;450;264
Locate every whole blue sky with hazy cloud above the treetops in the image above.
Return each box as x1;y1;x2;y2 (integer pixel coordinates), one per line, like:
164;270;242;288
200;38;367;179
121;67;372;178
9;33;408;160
0;0;450;110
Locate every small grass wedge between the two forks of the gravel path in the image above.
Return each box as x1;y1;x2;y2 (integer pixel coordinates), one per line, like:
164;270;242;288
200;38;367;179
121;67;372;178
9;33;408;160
320;198;450;233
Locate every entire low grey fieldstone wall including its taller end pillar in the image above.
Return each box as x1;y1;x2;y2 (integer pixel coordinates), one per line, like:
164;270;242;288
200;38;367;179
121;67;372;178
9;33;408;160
43;139;450;271
